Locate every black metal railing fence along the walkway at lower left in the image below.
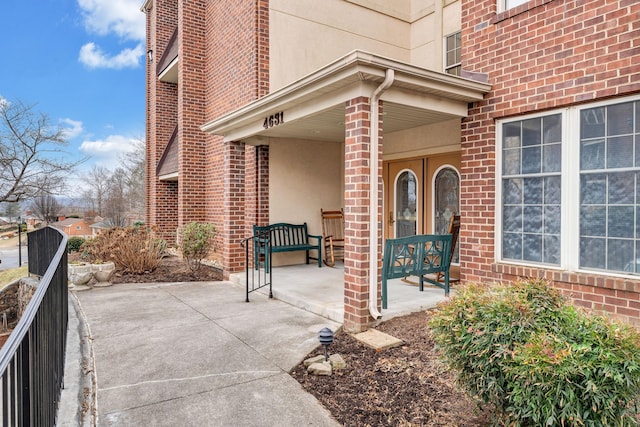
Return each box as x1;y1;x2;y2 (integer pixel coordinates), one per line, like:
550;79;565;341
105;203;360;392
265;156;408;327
0;227;68;426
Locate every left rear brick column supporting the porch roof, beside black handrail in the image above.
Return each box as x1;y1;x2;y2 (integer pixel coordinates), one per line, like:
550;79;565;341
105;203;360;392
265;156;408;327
222;142;245;280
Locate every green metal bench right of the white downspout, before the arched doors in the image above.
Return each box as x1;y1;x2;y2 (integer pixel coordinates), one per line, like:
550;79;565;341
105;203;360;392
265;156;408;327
382;234;452;309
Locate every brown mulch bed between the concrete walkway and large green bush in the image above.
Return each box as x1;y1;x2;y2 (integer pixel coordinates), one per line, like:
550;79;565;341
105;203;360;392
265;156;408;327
291;312;491;427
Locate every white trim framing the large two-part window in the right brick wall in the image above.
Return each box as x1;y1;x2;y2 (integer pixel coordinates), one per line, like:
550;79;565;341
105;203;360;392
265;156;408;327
494;95;640;279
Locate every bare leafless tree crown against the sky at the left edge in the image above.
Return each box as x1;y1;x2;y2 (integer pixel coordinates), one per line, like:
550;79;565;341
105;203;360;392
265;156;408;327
0;98;79;202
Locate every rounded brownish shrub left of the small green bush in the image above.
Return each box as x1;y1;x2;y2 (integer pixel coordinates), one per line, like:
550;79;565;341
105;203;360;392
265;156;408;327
82;227;167;274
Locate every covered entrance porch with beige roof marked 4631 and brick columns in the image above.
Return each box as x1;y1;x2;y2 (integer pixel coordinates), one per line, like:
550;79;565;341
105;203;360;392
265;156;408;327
201;51;489;331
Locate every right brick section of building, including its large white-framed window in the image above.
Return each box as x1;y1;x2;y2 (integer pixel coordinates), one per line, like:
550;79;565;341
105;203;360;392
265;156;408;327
460;0;640;325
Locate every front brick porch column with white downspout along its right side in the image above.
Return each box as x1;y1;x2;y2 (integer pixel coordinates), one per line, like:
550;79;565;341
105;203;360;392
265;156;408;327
344;97;382;332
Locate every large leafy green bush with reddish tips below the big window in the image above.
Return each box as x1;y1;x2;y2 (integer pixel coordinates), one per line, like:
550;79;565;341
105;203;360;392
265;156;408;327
430;280;640;426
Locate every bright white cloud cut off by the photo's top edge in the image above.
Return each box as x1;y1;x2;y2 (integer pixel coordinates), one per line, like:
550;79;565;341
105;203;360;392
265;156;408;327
78;0;145;41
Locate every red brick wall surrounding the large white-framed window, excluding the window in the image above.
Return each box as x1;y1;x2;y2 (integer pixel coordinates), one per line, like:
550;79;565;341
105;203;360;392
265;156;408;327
460;0;640;324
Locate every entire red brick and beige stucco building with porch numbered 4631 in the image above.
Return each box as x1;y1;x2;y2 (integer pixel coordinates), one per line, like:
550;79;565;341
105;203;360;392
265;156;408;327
142;0;640;330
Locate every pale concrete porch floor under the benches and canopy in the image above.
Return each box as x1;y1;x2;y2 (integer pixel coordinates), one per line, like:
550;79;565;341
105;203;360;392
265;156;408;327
230;263;455;323
